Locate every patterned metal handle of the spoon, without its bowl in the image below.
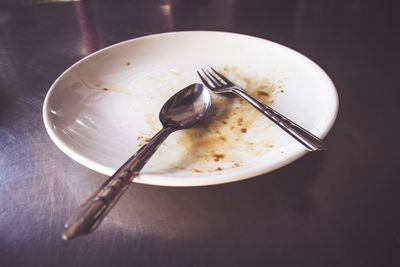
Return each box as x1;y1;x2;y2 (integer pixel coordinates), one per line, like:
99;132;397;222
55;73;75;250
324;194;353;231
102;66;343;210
62;128;173;240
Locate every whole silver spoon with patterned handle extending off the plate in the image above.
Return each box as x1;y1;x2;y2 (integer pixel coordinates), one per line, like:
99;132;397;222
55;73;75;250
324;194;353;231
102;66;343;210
62;83;211;240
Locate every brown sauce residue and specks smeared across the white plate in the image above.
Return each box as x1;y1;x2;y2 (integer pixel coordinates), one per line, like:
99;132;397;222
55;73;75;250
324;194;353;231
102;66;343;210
137;66;283;173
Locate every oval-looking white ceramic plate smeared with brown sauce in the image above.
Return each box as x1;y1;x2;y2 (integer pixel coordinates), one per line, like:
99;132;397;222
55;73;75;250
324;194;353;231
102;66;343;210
43;32;338;186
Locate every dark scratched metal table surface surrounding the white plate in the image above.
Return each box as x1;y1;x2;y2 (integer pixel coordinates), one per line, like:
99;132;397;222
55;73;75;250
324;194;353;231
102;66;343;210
0;0;400;267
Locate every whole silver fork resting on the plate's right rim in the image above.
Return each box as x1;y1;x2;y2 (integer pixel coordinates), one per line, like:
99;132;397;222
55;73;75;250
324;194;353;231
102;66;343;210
197;68;326;151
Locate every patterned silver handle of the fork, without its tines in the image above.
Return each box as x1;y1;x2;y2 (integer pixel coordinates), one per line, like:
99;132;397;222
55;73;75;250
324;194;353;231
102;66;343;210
232;88;326;151
